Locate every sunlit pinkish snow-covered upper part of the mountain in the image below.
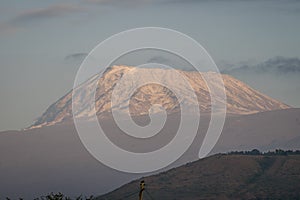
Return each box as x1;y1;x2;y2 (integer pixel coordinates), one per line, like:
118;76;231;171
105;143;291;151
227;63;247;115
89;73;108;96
32;66;289;128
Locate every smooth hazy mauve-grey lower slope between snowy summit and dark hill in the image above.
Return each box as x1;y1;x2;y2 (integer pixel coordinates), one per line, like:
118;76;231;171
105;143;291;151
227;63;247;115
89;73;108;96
0;108;300;200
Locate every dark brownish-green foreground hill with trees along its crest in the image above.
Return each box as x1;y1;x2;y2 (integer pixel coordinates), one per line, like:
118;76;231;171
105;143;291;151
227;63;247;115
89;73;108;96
97;154;300;200
